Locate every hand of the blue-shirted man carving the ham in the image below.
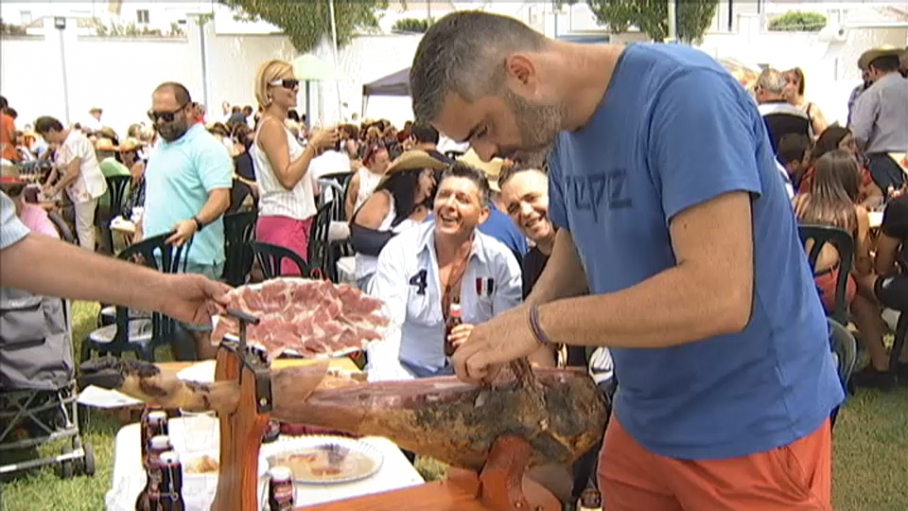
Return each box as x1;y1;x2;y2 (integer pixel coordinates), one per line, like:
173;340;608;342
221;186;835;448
451;307;539;383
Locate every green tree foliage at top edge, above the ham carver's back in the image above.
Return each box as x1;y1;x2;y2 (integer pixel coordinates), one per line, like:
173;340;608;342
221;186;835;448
555;0;719;42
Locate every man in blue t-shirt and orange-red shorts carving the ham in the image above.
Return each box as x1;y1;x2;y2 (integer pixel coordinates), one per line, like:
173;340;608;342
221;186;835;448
410;12;844;511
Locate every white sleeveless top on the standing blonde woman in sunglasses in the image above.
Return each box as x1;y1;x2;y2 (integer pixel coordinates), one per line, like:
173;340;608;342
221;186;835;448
252;128;317;220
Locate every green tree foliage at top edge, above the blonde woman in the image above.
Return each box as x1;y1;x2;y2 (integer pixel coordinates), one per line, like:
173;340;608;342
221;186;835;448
220;0;388;53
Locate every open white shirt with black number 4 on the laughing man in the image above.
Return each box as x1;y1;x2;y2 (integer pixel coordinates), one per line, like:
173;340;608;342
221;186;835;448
369;221;522;380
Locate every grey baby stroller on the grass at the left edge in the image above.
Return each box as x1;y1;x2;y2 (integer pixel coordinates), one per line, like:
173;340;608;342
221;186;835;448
0;288;95;478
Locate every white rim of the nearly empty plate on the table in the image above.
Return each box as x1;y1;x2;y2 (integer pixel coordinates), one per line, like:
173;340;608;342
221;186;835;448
262;435;384;484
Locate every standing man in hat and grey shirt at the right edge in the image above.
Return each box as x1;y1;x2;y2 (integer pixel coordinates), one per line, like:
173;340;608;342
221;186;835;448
851;46;908;191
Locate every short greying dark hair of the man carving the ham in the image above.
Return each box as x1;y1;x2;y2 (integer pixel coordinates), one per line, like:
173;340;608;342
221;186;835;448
410;11;547;122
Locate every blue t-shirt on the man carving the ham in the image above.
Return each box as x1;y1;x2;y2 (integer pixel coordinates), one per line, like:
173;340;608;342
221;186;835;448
549;44;844;459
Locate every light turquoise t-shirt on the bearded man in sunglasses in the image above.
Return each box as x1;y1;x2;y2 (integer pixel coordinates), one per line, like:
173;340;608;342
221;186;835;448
142;124;233;266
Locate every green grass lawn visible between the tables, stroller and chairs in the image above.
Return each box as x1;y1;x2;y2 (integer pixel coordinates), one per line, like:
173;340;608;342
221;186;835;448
0;303;908;511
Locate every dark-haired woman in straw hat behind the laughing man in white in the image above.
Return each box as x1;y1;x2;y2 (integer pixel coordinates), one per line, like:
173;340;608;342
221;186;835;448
350;150;448;292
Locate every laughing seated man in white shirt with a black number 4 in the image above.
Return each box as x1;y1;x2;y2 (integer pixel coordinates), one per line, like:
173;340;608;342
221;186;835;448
364;162;524;380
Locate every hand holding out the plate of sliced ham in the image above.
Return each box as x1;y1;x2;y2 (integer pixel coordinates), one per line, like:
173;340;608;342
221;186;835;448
156;274;230;325
